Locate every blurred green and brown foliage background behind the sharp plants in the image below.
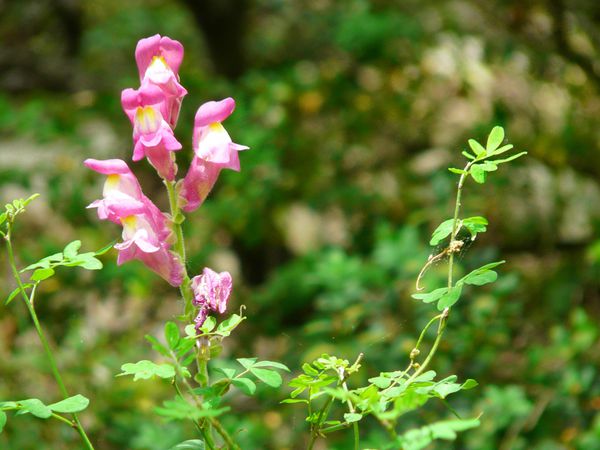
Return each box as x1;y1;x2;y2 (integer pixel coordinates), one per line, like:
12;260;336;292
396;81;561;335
0;0;600;450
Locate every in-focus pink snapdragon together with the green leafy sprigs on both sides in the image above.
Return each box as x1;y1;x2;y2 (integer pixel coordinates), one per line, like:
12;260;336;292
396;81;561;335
0;35;524;449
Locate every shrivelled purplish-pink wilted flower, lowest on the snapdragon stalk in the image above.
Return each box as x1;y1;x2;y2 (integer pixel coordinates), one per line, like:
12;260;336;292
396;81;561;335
192;267;233;328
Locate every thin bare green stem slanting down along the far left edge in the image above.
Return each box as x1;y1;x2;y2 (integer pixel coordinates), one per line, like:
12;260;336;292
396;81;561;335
4;229;94;450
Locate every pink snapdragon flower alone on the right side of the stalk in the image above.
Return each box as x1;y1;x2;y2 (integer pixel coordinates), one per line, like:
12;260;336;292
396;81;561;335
180;97;248;212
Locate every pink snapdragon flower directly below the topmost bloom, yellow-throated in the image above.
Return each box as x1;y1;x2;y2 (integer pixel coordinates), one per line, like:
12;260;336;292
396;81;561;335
121;85;181;181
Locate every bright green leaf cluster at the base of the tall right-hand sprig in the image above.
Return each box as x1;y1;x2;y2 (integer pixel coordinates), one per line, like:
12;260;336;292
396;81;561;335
282;354;477;449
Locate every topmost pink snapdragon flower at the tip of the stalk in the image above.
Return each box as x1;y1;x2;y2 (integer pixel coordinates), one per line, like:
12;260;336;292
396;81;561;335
135;34;187;128
